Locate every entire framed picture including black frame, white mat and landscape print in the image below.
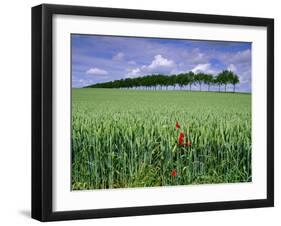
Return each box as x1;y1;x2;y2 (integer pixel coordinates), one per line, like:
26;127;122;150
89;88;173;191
31;4;274;221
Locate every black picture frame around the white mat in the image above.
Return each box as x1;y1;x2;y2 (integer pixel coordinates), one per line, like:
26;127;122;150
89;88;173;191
32;4;274;221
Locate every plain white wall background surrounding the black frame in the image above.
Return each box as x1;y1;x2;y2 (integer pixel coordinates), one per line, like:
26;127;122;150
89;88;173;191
0;0;276;226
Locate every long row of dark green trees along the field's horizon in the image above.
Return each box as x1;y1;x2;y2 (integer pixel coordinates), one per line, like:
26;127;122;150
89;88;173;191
87;70;239;92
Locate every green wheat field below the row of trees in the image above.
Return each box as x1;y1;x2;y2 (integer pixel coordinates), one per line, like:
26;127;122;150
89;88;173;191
72;88;251;190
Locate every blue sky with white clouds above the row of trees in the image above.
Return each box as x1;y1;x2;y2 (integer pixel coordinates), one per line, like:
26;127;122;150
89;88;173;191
71;34;252;92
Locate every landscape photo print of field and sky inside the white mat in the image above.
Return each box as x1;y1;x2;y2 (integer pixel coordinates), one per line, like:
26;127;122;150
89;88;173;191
71;34;252;190
